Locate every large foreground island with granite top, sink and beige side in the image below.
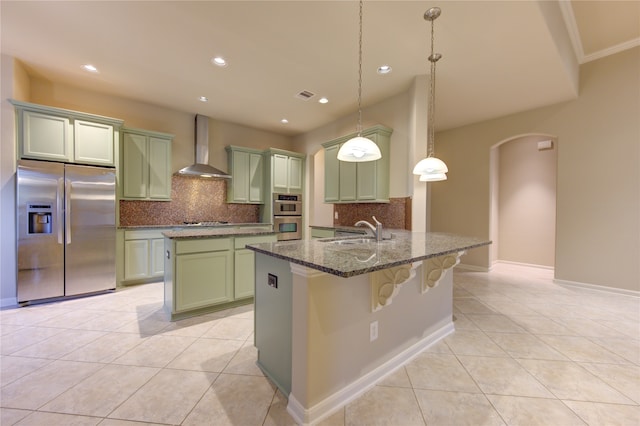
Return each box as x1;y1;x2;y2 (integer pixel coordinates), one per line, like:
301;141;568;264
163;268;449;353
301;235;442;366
247;230;490;424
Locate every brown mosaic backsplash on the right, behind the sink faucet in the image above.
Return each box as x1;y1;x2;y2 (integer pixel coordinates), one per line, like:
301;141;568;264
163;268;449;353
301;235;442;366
333;197;411;230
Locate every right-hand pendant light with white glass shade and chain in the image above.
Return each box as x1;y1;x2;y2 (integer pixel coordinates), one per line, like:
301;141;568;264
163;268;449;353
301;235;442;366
413;7;449;182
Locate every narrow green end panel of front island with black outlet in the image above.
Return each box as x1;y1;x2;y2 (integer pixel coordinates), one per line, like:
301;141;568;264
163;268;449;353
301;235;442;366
254;253;292;397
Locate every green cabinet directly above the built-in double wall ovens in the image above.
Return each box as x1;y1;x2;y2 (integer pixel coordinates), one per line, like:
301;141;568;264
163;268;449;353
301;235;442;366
265;148;305;194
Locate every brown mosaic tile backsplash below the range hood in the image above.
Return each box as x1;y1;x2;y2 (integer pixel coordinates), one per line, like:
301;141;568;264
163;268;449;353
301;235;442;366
120;176;260;226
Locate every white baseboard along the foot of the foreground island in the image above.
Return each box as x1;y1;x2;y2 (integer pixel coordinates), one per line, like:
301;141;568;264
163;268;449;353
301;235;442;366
287;320;455;425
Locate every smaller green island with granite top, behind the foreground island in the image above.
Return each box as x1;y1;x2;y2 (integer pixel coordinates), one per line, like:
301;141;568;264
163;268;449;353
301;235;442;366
163;224;276;321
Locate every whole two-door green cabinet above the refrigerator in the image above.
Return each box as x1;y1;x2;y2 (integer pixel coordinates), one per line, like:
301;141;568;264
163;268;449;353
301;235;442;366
11;100;122;167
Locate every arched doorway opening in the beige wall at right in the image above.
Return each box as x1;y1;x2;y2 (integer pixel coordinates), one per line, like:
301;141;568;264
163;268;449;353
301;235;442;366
490;134;557;268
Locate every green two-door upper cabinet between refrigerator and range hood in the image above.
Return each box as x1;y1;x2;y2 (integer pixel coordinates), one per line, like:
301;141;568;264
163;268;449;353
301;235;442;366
121;128;173;200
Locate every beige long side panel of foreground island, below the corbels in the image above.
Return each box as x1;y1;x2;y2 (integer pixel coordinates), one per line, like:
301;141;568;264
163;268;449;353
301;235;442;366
290;265;453;412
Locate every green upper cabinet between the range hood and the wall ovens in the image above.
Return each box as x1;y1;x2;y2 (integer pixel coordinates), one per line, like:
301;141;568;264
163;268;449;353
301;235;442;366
225;146;264;204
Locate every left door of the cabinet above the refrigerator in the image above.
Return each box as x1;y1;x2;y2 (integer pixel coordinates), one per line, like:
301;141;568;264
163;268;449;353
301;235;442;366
21;111;73;162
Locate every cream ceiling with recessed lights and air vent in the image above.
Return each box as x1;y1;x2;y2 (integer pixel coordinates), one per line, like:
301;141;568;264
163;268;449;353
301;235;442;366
0;0;640;135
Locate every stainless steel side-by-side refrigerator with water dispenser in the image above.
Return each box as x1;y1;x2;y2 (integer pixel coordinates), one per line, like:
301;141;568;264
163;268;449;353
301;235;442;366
16;160;116;303
